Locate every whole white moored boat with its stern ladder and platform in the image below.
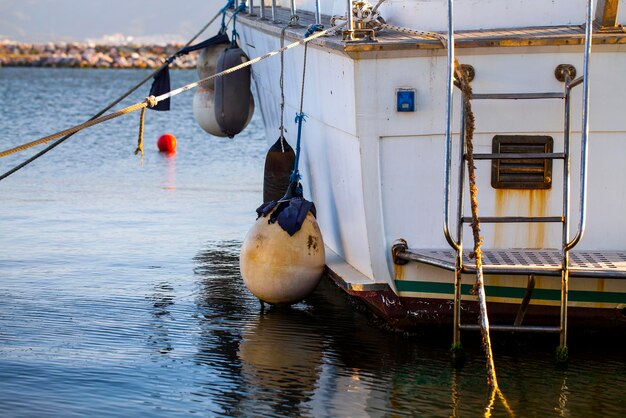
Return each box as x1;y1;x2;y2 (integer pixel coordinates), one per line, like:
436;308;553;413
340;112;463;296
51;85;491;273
230;0;626;348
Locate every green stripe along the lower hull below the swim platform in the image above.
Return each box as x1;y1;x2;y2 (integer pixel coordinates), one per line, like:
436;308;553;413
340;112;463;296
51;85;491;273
395;280;626;304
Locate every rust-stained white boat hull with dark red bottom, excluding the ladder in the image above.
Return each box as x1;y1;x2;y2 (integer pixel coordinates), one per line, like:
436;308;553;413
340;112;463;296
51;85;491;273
234;6;626;330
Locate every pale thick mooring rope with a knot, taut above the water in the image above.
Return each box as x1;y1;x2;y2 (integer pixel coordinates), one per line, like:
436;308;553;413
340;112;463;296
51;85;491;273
0;23;345;163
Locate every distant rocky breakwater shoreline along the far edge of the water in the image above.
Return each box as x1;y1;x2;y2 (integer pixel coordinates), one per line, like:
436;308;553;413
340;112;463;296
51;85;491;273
0;41;196;69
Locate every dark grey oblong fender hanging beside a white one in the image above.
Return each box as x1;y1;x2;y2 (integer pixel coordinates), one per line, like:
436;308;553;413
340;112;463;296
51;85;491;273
215;47;254;138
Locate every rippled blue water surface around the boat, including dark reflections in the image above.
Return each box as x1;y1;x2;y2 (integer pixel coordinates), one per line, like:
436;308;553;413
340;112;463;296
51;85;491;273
0;68;626;417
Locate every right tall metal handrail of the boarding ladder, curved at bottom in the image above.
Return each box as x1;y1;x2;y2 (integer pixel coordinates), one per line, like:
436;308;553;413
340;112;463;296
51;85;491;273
563;0;593;251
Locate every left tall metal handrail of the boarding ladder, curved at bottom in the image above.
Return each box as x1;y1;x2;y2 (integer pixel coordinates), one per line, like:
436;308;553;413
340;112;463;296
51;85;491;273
443;0;460;251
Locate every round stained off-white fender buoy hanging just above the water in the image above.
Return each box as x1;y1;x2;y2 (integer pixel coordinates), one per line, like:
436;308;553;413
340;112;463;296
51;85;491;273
239;212;325;305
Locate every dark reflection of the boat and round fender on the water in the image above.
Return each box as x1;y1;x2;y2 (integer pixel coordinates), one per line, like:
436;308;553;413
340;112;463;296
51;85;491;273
193;242;625;416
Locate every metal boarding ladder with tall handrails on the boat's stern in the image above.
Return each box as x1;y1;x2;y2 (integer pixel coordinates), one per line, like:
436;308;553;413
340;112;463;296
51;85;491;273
443;0;593;358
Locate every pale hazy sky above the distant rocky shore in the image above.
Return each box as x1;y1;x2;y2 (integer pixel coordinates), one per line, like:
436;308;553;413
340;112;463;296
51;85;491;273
0;0;226;43
